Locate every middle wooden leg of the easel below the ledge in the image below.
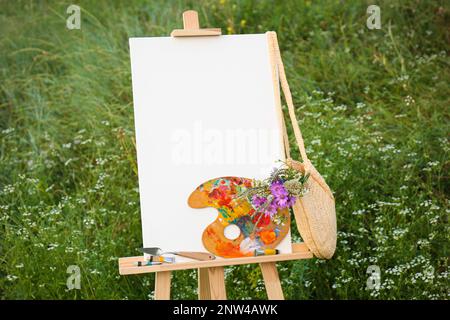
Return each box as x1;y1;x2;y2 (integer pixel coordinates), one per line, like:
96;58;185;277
198;267;227;300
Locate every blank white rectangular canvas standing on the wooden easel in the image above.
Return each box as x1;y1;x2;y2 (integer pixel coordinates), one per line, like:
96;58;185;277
130;34;291;253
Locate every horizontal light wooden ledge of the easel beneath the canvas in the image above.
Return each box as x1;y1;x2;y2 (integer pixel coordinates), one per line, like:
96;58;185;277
119;242;313;275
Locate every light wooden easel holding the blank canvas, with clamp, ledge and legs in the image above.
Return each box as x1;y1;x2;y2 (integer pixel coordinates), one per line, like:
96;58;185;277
119;10;313;300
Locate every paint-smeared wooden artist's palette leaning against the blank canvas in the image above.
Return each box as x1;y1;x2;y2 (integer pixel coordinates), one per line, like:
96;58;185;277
188;177;290;258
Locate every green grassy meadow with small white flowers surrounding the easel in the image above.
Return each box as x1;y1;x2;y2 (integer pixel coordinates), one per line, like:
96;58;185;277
0;0;450;299
